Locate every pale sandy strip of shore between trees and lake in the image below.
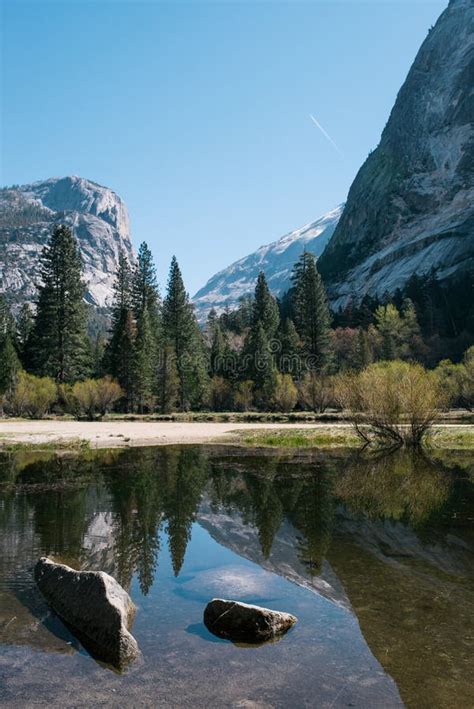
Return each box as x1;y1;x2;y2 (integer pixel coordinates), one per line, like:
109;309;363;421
0;419;346;448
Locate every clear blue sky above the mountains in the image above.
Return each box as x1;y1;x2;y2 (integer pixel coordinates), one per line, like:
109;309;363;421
0;0;447;294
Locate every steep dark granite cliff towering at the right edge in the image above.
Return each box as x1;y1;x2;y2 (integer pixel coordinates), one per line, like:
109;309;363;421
319;0;474;307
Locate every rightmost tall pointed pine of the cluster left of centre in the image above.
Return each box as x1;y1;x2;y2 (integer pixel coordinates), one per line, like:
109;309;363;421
162;256;207;411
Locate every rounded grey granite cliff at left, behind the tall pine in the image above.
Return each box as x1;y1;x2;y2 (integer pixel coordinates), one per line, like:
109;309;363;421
0;177;133;306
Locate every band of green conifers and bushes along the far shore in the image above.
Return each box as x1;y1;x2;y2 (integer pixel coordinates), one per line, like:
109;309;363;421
0;225;474;418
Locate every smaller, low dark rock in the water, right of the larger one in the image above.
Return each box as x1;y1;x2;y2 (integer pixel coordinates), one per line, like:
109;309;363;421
204;598;297;643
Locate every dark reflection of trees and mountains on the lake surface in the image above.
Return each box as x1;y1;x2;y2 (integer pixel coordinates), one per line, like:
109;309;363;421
0;447;474;707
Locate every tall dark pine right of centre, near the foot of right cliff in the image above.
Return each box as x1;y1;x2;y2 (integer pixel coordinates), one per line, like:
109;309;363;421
292;252;331;372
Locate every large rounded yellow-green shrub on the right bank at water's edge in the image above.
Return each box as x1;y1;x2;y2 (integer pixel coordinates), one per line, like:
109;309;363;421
337;361;445;446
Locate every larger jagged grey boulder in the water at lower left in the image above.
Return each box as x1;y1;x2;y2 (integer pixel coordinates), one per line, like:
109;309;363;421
35;557;139;668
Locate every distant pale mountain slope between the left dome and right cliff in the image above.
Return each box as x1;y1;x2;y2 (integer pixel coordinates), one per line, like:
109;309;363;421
193;205;344;321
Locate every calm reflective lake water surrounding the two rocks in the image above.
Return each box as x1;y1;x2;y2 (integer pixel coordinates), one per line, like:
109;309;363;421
0;447;474;709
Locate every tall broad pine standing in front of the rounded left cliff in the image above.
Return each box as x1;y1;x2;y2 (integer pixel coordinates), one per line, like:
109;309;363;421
32;225;90;382
